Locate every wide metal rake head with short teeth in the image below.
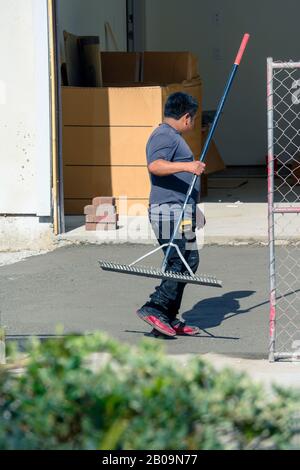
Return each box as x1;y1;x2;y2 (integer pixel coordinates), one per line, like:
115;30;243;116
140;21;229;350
99;261;222;287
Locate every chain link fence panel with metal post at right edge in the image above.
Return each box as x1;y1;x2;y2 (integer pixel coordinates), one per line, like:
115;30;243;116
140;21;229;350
268;59;300;361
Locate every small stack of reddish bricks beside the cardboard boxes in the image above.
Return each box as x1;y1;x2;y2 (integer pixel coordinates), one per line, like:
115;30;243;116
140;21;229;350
84;197;119;232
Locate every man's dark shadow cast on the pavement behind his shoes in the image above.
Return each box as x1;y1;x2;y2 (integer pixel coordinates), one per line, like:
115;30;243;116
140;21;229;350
182;291;256;331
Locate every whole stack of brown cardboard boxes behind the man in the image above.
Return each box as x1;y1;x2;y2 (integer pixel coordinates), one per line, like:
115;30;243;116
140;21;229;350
62;53;225;215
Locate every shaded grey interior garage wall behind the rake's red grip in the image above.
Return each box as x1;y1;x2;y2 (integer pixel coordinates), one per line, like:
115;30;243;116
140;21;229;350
146;0;300;165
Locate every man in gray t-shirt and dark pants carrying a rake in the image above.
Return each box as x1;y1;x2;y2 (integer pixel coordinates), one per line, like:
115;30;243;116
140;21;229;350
137;93;205;336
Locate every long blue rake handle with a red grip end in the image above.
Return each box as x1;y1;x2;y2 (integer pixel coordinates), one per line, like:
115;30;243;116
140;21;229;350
162;34;250;272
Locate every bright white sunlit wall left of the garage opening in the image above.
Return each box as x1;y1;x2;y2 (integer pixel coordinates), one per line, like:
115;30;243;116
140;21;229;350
0;0;51;216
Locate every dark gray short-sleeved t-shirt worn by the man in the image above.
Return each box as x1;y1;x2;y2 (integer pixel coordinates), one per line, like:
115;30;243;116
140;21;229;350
147;123;199;206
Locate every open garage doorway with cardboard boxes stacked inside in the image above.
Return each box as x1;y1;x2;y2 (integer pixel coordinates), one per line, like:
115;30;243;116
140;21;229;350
56;0;300;235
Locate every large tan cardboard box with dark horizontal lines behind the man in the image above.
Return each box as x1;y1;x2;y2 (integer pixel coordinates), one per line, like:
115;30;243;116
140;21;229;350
63;79;202;214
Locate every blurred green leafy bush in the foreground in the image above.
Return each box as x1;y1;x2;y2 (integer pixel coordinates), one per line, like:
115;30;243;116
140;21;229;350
0;334;300;450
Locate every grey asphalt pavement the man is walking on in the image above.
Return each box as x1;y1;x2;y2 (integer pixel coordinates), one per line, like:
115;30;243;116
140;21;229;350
0;245;268;359
